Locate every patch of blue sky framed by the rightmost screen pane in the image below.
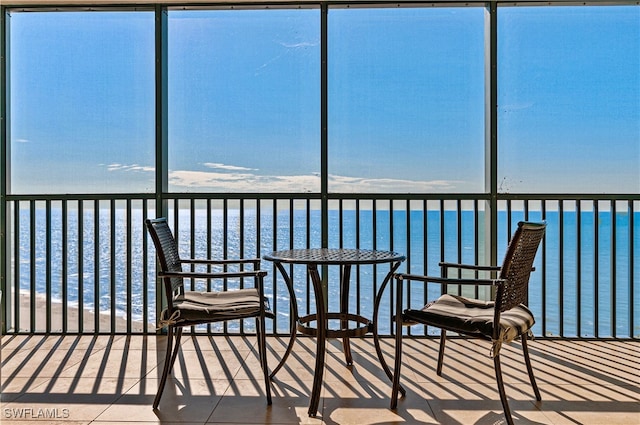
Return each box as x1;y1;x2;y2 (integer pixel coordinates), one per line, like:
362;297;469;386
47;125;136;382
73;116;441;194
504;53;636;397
498;7;640;193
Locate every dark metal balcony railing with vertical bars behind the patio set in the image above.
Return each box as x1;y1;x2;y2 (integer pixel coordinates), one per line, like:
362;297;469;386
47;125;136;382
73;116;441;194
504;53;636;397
3;194;640;338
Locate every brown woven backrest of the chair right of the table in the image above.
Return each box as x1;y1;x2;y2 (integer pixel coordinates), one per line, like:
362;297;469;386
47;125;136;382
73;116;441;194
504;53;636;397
496;221;547;312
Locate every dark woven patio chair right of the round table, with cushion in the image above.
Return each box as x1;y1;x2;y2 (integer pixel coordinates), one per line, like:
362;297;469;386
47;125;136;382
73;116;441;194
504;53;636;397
391;222;546;424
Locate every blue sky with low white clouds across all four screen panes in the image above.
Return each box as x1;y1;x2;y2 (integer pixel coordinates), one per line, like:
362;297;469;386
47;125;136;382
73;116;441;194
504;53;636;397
10;6;640;193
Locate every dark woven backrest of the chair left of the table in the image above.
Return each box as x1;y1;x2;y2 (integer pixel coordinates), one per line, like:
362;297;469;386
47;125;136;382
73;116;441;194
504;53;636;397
145;217;184;298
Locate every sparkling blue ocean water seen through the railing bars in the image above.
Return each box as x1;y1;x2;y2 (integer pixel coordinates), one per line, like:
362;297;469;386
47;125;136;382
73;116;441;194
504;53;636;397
12;208;640;337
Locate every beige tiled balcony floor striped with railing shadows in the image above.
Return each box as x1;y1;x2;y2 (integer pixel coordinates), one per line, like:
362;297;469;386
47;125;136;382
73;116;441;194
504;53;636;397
0;336;640;425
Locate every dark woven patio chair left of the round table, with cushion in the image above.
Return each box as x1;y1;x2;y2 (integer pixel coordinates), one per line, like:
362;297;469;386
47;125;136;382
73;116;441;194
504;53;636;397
145;218;274;409
